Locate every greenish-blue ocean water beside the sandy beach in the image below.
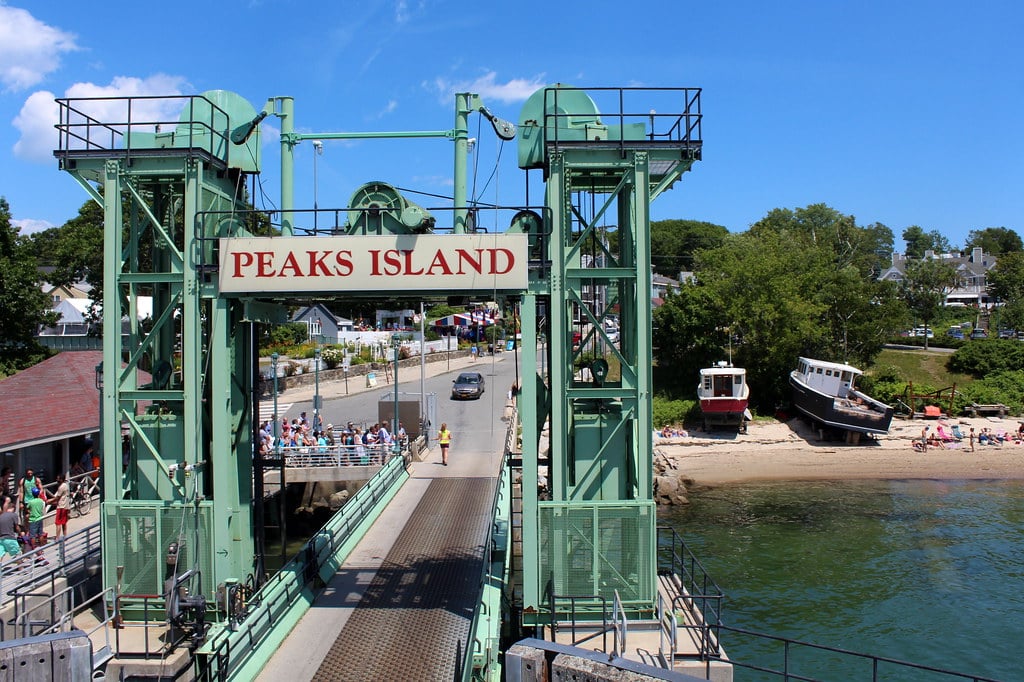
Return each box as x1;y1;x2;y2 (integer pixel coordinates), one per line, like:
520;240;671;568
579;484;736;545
660;480;1024;682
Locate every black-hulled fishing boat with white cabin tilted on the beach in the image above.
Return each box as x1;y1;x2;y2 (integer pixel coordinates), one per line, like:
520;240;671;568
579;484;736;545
790;357;893;439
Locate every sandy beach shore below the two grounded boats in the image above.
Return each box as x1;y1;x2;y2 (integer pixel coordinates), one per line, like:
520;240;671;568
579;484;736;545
654;411;1024;484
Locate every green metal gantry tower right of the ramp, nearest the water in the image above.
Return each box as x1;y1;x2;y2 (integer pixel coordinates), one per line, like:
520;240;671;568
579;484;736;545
519;86;701;626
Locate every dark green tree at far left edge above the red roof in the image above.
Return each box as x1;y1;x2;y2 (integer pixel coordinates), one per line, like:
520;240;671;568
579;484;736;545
0;197;57;376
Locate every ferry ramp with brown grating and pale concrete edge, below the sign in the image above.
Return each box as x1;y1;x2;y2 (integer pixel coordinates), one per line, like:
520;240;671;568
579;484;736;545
257;387;507;682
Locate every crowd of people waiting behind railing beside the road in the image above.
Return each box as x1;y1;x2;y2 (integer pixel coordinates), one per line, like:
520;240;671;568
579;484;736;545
259;412;409;465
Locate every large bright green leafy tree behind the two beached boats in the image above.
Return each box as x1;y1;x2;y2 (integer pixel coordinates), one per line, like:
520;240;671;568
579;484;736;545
688;204;906;413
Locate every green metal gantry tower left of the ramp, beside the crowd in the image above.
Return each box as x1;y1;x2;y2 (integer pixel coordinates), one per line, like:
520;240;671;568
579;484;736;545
54;91;269;608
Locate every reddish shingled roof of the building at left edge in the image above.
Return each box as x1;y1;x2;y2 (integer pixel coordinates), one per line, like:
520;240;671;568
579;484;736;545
0;350;103;451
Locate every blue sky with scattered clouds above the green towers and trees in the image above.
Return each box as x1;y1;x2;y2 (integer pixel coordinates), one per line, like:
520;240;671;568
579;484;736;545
0;0;1024;250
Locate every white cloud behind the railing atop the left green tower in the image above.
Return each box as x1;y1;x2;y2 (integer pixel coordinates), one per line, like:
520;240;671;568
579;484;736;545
13;74;187;162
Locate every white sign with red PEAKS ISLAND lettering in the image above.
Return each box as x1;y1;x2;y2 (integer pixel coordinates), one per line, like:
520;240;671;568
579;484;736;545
218;233;528;294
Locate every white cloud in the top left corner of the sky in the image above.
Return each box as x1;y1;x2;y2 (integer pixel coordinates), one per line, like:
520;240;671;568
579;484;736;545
0;4;78;91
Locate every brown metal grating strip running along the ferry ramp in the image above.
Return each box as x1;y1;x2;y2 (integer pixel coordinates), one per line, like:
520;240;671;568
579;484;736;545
310;478;495;682
